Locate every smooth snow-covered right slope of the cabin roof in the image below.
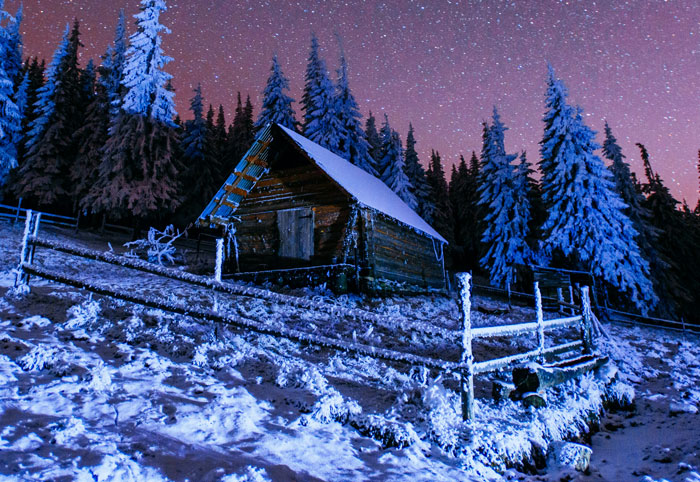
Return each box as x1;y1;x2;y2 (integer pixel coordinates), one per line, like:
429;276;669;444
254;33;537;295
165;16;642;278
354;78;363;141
277;124;447;243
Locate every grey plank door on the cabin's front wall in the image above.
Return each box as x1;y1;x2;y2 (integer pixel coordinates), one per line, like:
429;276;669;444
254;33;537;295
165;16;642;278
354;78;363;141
277;208;314;261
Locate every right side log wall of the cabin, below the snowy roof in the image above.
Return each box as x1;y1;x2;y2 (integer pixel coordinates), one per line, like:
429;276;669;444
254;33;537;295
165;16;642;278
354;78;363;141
363;210;445;289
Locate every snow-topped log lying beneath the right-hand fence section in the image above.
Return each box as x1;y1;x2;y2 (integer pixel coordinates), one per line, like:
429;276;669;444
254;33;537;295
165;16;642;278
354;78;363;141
513;355;608;393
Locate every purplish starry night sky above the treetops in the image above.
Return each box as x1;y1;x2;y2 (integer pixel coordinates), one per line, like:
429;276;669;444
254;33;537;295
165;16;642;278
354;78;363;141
15;0;700;206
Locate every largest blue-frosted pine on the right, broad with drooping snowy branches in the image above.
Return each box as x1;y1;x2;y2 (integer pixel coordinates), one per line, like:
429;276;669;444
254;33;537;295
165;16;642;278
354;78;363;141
540;66;657;312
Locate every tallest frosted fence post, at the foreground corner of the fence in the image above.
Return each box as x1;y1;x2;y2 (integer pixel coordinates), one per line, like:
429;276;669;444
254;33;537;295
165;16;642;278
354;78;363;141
456;273;474;421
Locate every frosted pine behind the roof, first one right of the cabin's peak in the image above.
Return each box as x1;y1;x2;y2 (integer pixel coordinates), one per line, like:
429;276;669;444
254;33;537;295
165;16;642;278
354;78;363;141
301;35;347;153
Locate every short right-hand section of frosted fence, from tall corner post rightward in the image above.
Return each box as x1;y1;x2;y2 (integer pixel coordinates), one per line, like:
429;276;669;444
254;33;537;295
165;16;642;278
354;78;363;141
457;273;593;420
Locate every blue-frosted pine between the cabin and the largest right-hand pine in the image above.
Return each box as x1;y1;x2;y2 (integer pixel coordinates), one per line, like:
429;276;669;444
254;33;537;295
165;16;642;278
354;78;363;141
479;107;532;290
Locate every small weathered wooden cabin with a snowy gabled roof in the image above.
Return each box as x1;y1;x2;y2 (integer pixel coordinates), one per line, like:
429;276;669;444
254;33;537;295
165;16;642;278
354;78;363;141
198;125;447;292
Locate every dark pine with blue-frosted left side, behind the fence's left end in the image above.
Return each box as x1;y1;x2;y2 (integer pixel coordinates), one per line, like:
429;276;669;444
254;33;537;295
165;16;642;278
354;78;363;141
14;20;83;209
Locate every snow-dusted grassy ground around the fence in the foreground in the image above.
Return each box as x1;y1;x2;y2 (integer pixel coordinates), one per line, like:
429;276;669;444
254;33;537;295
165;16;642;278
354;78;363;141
0;224;700;481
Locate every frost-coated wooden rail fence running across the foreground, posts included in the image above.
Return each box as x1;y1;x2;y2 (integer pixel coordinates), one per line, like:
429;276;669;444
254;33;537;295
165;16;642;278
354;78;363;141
15;211;592;420
